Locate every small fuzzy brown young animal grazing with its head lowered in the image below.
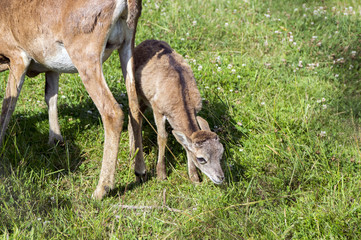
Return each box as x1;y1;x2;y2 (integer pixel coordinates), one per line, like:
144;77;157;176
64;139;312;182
129;40;224;184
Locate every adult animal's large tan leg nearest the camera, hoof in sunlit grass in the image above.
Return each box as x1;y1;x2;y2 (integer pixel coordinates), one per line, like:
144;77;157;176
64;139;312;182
68;47;124;200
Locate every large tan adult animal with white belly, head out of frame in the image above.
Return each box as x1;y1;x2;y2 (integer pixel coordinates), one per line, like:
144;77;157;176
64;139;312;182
0;0;145;199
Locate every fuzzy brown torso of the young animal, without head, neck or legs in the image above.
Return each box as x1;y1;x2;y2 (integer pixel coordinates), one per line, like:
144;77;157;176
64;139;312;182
134;40;202;122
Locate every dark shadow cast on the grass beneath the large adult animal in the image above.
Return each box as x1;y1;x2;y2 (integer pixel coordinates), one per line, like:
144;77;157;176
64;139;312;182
0;89;145;199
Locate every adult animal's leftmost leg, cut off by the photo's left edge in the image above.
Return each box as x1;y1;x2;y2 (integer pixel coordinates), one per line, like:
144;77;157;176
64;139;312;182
0;52;30;144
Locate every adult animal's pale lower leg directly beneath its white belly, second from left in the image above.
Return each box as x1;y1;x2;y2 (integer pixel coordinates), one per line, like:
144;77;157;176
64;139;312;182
45;72;63;145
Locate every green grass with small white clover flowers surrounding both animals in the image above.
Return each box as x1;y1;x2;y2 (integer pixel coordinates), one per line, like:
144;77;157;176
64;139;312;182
0;0;361;239
